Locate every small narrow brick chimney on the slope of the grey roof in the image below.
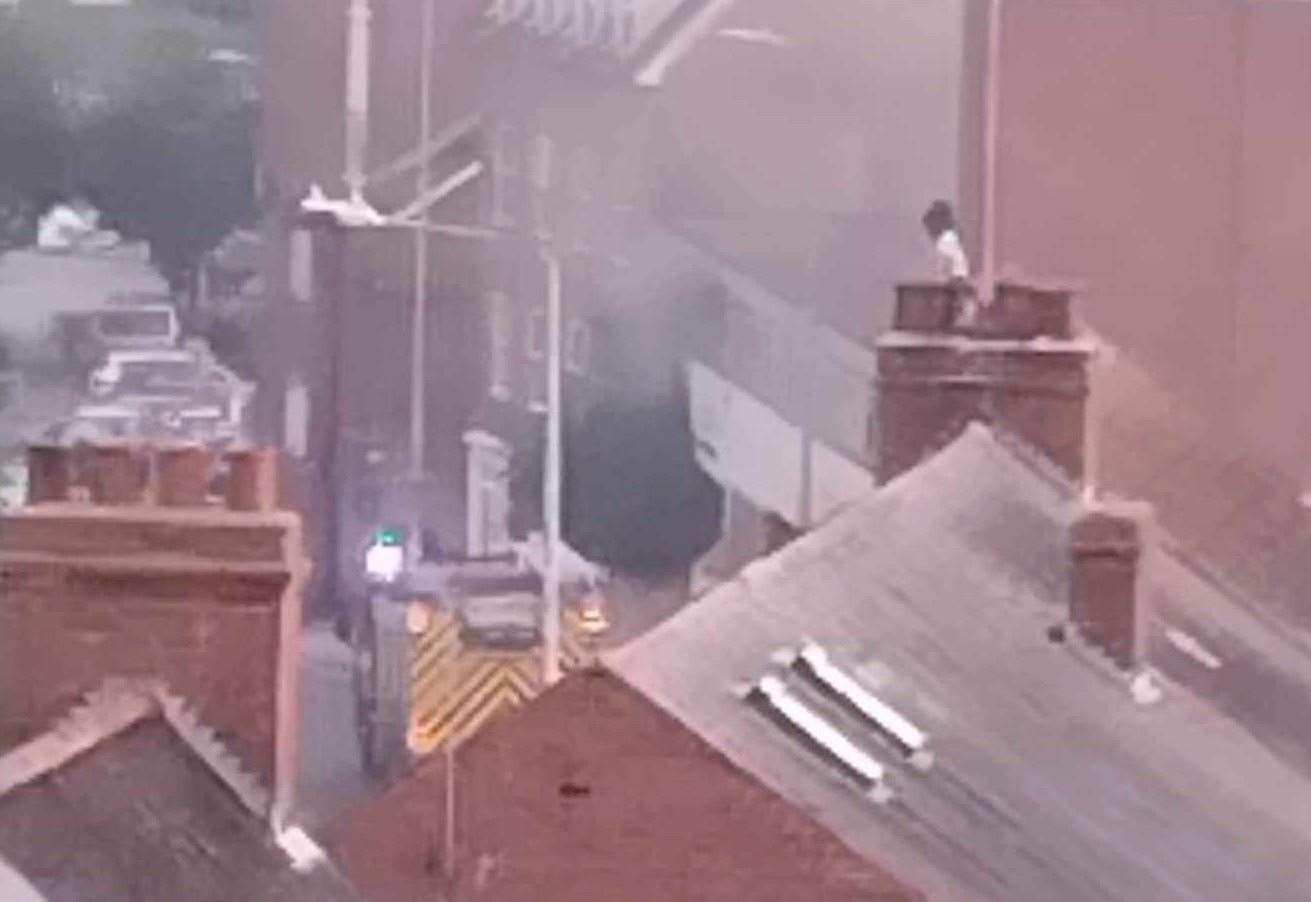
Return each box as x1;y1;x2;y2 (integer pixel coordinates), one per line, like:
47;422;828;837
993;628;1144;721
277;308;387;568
1070;502;1152;670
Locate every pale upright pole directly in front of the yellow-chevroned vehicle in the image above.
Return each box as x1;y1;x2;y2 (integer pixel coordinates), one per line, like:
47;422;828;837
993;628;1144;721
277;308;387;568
541;249;562;686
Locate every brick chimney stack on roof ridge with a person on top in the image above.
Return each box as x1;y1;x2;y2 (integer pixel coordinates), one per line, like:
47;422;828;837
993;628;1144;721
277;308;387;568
873;282;1093;482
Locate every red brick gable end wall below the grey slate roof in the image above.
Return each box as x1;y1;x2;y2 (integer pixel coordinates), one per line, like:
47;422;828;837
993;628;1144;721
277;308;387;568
329;670;923;902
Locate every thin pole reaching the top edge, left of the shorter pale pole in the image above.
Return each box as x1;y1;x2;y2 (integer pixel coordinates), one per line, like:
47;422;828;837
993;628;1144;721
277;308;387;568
410;0;434;480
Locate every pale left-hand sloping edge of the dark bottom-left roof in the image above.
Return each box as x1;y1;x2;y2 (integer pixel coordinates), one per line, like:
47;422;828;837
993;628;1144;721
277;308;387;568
0;677;157;796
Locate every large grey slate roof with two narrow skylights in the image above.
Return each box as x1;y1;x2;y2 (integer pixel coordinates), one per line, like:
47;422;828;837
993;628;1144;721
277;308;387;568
606;425;1311;902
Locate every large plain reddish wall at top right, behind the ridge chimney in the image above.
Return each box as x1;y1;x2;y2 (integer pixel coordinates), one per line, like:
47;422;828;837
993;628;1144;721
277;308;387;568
985;0;1311;476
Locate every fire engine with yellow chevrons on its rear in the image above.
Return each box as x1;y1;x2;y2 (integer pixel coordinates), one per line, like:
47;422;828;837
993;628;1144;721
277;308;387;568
351;528;607;777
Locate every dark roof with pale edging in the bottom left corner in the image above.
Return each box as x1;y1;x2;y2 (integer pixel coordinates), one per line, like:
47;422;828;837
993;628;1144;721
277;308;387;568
0;682;358;902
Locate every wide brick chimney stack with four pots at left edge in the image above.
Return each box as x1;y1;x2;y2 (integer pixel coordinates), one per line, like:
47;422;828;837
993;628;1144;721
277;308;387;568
0;446;308;815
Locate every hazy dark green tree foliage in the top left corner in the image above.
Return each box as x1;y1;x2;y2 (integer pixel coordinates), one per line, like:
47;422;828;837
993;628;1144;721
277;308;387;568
0;8;256;290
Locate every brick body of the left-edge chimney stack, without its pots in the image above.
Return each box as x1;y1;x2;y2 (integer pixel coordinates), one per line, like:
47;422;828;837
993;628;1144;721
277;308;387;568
0;505;302;785
